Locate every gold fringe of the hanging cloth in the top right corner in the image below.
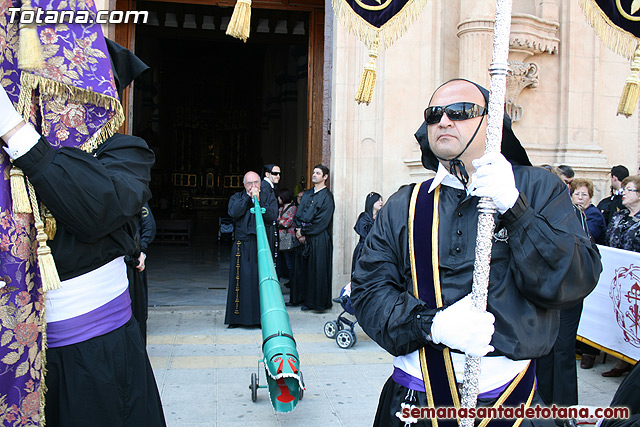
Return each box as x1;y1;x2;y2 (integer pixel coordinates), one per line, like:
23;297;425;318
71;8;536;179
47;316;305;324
579;0;639;59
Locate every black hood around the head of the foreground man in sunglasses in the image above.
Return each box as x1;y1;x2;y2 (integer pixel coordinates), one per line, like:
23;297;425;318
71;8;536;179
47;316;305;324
415;79;531;171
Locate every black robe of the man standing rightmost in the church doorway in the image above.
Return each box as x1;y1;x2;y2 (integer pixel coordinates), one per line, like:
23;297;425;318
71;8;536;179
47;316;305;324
291;187;335;311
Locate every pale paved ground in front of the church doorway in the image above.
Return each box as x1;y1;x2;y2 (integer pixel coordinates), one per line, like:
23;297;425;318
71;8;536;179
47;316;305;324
147;246;622;427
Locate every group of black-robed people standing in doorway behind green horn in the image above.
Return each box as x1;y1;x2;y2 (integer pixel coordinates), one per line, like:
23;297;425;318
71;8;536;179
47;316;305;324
225;164;335;328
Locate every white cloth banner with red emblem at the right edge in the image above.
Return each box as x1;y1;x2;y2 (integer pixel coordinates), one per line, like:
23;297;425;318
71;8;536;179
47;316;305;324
578;245;640;360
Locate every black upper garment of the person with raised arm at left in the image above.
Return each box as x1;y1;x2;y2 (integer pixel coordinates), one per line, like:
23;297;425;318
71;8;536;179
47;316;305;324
14;134;154;280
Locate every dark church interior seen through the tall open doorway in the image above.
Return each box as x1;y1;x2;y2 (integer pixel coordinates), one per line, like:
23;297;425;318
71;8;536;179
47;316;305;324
132;2;308;244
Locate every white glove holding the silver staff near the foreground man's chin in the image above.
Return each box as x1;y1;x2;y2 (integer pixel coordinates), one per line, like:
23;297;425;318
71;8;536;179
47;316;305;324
471;153;520;214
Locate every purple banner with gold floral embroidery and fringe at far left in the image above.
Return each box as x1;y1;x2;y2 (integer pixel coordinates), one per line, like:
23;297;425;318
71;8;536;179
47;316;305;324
0;0;123;427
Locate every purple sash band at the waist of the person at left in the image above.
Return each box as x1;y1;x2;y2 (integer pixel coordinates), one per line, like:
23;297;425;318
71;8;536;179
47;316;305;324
47;289;131;348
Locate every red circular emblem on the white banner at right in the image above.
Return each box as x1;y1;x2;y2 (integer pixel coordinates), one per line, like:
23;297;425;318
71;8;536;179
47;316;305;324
609;264;640;347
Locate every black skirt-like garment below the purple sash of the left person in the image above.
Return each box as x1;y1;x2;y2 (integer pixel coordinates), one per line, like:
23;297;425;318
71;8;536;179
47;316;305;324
45;317;166;427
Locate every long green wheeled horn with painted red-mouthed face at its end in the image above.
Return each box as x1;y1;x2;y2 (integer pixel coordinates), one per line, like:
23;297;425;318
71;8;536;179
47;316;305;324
249;198;304;412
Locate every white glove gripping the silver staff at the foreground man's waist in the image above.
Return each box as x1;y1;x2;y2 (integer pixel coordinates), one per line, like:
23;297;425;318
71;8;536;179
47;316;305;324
431;294;496;357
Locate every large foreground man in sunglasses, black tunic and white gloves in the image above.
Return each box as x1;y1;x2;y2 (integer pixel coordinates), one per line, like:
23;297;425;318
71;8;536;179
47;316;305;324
351;79;602;426
